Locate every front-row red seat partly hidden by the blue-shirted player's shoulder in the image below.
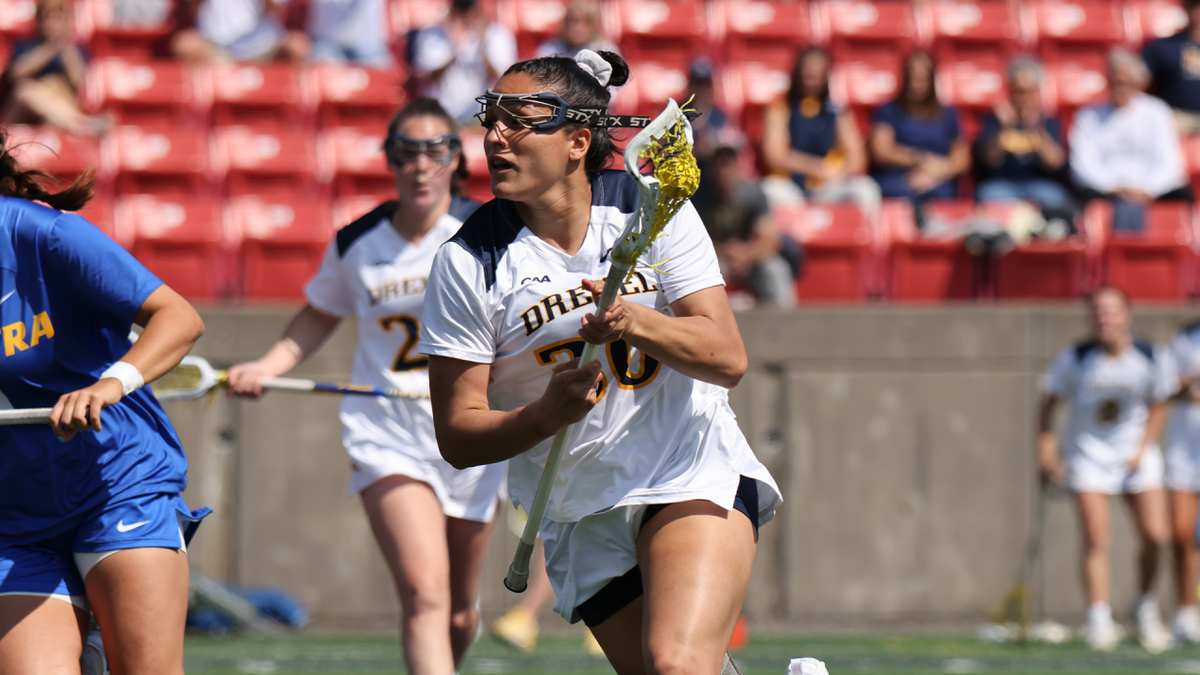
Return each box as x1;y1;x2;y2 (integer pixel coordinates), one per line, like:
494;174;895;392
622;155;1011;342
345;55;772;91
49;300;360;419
116;195;228;298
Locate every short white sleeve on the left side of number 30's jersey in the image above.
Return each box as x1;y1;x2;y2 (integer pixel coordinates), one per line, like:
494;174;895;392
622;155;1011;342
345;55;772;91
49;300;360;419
420;241;496;363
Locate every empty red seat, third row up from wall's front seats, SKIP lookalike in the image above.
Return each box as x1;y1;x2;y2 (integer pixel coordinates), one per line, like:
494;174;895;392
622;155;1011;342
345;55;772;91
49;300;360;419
212;125;324;193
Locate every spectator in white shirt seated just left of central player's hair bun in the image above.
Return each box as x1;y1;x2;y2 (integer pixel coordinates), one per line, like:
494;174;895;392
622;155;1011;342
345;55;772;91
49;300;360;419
413;0;517;125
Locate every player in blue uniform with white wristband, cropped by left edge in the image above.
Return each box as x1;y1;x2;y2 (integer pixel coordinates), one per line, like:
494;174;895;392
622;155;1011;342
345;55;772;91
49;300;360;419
0;135;206;675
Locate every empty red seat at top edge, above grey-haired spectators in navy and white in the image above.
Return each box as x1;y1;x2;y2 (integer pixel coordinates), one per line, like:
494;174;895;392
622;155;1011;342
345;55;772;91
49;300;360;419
1030;0;1126;48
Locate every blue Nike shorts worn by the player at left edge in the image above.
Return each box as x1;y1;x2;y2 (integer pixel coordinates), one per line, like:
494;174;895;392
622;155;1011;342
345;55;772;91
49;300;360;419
0;492;212;607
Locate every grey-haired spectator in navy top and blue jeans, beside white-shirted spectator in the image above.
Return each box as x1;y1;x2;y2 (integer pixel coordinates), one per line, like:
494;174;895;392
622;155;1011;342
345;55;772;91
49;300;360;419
976;58;1073;220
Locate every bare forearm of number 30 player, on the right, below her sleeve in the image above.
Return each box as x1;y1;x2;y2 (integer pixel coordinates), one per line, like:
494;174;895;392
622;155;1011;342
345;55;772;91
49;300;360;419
624;303;746;388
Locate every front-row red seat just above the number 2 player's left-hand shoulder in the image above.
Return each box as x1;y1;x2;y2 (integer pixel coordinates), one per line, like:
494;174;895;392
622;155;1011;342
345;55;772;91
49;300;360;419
227;193;335;299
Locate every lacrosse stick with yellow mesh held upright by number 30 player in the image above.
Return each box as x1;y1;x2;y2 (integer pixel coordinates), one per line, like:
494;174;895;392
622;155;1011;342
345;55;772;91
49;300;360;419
504;98;700;593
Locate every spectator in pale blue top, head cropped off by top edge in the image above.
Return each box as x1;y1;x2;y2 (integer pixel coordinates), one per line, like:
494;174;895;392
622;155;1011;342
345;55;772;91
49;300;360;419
308;0;392;68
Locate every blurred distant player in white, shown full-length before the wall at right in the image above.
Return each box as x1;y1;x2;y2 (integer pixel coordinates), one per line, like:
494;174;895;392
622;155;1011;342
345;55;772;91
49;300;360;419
1038;288;1175;651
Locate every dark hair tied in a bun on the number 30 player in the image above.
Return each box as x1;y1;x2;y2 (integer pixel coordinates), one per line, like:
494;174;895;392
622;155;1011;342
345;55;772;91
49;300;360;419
504;52;629;179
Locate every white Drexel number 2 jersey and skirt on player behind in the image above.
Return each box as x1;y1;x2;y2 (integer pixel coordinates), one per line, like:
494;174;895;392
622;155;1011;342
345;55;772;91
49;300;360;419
305;197;478;461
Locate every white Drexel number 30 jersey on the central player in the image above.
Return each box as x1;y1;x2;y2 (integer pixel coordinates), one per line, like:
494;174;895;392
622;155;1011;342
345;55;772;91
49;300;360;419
421;171;781;524
